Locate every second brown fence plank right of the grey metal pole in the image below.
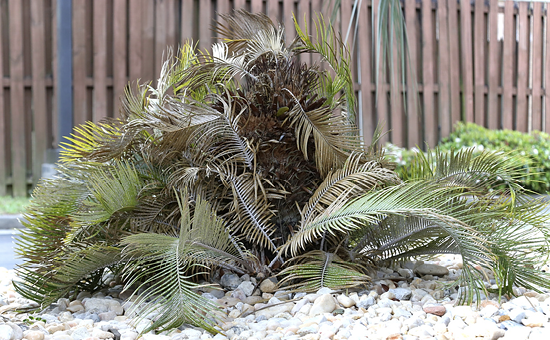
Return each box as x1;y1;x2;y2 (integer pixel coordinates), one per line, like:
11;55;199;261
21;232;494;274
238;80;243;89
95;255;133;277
93;0;107;122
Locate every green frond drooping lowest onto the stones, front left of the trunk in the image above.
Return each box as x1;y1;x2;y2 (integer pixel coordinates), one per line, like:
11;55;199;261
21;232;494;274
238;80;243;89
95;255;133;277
122;196;235;332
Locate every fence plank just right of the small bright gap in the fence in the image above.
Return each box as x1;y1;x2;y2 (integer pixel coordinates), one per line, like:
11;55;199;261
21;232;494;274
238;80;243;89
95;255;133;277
501;1;516;130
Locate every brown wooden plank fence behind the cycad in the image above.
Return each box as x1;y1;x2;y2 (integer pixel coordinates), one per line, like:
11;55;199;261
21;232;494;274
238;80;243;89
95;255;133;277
0;0;550;196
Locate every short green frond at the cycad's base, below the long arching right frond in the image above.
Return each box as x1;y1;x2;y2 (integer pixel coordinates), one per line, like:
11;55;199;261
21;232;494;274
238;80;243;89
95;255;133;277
279;250;370;292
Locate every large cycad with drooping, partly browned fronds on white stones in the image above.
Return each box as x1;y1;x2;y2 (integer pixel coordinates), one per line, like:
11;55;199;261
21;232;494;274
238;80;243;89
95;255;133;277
15;11;549;331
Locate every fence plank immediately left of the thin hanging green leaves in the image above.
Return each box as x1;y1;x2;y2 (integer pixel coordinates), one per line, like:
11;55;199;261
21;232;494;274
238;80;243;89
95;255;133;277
357;0;376;146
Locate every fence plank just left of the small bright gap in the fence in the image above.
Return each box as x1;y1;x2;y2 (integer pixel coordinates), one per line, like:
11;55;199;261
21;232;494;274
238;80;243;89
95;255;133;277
487;0;501;130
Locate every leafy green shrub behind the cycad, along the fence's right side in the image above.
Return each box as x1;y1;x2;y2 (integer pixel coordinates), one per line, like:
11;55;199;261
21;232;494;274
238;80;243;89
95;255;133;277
386;123;550;194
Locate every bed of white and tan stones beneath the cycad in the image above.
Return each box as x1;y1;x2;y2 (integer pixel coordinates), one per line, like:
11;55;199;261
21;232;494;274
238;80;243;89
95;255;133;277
0;256;550;340
